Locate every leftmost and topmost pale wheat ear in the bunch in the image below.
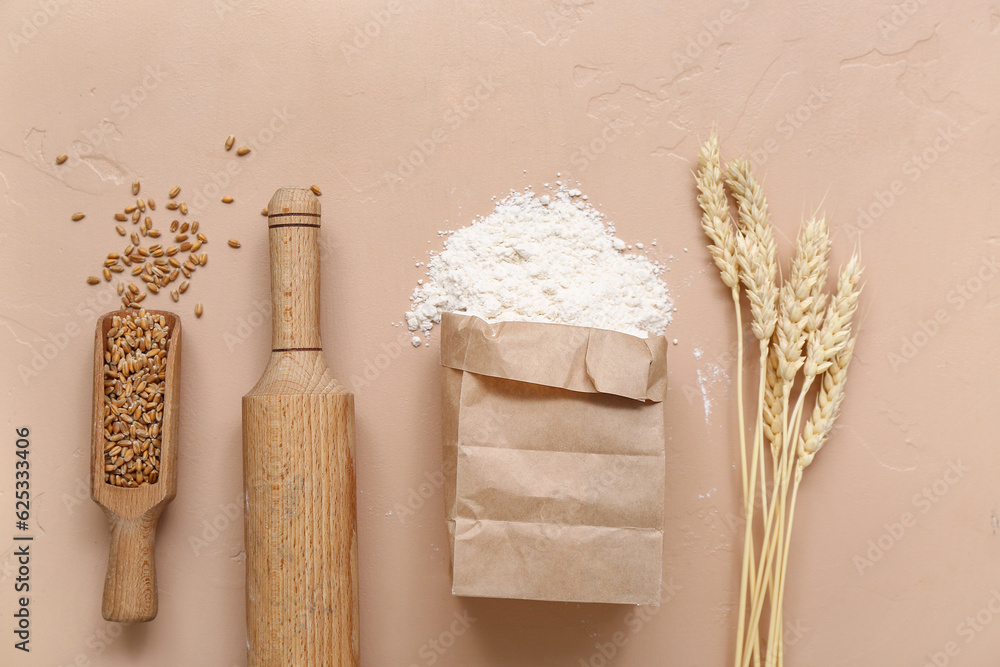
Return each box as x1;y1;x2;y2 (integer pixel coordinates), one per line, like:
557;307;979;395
695;131;739;289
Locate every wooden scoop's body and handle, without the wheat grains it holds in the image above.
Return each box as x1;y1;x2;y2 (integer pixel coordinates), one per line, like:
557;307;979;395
90;310;181;623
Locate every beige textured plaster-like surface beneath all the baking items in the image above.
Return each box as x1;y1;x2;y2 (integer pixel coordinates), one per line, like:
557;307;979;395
0;0;1000;667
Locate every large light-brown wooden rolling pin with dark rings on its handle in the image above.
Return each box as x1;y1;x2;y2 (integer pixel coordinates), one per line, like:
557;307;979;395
243;188;360;667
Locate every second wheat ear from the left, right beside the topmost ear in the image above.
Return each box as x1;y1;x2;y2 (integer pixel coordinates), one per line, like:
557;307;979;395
726;158;778;341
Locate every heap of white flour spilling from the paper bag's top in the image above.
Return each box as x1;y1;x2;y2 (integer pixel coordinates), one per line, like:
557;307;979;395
406;187;673;345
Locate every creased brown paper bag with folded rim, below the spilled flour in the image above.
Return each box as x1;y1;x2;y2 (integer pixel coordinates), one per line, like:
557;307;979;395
441;314;667;604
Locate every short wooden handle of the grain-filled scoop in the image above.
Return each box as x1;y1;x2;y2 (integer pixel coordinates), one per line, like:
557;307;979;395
101;506;162;623
